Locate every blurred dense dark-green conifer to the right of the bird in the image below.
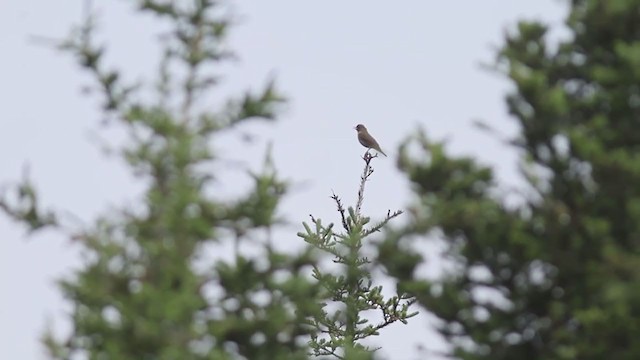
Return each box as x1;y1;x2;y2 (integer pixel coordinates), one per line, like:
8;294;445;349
379;0;640;360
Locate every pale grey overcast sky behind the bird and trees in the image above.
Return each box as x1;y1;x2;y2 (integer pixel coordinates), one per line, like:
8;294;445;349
0;0;565;359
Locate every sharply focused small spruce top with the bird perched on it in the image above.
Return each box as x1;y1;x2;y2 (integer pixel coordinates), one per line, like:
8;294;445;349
298;151;417;360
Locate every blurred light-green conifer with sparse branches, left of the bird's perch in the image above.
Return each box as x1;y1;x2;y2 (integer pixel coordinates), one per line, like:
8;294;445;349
0;0;321;360
